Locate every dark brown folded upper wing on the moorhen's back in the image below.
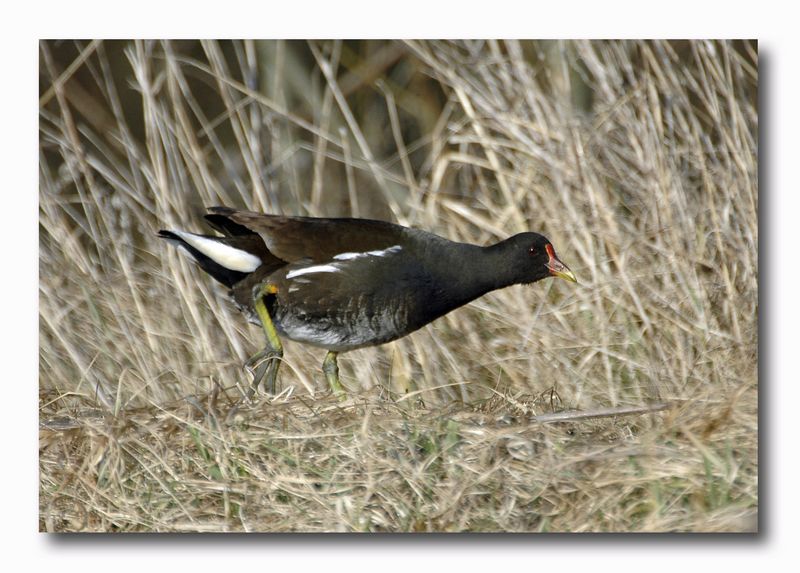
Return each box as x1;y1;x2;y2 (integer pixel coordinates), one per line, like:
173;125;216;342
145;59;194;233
209;207;406;263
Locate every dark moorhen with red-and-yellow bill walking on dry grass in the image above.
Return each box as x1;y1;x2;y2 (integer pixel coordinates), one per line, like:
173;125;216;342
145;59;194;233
159;207;577;397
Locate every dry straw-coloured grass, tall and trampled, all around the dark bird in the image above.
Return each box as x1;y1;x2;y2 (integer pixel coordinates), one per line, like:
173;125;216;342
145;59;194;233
39;41;758;531
